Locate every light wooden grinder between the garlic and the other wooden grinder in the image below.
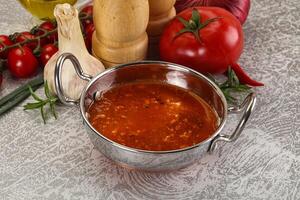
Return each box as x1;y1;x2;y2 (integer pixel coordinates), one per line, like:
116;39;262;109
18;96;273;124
92;0;149;67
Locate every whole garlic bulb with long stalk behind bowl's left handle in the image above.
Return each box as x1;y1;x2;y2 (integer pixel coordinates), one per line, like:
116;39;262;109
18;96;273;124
44;4;105;100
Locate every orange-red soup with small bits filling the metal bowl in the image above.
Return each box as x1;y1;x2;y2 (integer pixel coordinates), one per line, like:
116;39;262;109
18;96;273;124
88;82;218;151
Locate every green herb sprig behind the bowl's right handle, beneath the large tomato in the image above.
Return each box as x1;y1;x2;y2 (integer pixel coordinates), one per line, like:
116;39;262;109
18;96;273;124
209;67;251;104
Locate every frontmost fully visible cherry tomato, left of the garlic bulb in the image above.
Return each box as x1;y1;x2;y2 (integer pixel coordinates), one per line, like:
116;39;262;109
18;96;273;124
7;47;38;78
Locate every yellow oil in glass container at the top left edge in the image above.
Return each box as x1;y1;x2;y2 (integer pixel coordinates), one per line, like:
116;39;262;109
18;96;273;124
18;0;77;19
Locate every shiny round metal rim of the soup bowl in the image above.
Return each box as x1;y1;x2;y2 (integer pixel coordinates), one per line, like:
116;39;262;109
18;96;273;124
80;60;228;154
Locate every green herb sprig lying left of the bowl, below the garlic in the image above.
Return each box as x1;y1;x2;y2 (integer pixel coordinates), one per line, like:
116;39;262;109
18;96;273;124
24;81;58;124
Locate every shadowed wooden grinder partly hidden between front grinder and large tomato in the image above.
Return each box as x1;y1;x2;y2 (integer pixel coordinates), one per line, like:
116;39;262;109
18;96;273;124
147;0;176;59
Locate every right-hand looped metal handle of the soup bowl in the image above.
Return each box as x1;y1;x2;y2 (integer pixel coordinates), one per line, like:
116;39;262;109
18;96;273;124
208;93;256;153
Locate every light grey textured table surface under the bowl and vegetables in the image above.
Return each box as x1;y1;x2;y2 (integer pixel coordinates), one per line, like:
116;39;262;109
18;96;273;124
0;0;300;200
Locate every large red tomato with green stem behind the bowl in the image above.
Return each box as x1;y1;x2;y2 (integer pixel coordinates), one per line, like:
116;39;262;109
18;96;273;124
160;7;244;74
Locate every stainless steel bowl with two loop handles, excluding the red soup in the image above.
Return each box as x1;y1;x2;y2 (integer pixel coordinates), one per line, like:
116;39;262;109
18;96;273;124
55;53;256;171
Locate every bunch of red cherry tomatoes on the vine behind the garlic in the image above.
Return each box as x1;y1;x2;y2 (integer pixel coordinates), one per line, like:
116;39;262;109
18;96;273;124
0;5;94;86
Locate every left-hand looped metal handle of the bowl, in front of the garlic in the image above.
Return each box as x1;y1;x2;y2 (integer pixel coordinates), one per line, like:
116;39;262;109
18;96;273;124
54;53;93;106
